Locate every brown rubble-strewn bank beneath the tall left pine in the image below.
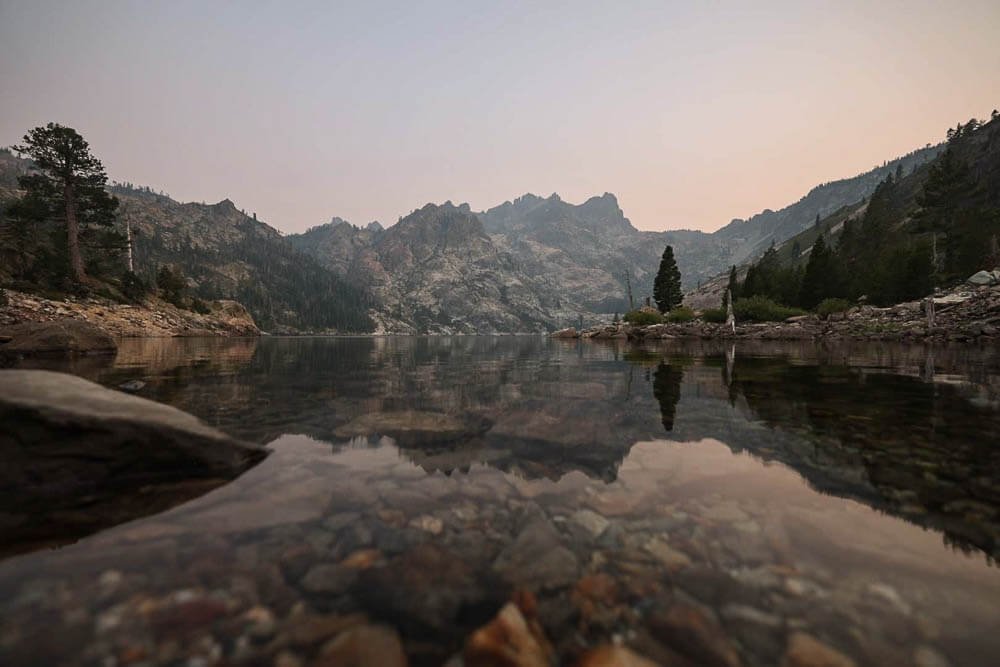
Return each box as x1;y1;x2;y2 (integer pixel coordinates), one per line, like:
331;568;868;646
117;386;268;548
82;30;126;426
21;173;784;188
0;289;260;338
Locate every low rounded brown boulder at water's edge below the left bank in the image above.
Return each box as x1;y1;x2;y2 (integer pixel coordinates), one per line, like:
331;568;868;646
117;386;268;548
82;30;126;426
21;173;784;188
0;318;118;357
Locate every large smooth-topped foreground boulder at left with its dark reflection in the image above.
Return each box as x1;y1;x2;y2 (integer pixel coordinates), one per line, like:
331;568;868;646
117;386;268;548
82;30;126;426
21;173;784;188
0;370;266;550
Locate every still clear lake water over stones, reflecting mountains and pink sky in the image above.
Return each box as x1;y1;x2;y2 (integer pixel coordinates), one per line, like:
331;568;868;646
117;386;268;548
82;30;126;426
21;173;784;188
0;337;1000;667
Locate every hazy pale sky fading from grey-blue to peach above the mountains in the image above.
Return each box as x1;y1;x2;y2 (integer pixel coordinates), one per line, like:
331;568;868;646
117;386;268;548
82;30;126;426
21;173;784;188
0;0;1000;231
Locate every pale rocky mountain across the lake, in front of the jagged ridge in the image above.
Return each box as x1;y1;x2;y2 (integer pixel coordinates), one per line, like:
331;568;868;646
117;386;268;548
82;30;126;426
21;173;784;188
288;202;560;333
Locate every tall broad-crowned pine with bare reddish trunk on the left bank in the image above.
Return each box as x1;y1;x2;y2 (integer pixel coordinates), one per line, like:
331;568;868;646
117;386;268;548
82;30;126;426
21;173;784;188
11;123;123;284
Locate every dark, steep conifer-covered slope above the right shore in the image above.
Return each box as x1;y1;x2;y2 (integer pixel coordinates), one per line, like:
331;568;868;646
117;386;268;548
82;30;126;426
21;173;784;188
737;112;1000;308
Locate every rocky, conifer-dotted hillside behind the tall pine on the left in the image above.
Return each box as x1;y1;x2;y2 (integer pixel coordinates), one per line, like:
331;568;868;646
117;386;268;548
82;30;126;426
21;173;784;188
0;152;374;332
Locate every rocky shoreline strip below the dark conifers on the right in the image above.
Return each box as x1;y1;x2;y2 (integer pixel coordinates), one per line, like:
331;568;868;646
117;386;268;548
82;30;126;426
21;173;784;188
551;285;1000;343
